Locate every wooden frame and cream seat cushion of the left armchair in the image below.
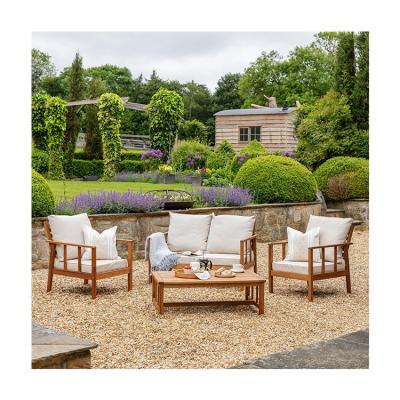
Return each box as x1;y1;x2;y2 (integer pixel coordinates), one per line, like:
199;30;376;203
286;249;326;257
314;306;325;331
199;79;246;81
44;221;133;299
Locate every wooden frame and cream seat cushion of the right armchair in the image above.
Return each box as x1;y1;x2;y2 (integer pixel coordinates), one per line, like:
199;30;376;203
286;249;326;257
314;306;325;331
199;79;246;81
268;217;361;301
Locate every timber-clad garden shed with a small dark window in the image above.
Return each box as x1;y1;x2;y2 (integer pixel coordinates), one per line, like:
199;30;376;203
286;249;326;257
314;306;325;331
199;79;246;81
214;106;297;152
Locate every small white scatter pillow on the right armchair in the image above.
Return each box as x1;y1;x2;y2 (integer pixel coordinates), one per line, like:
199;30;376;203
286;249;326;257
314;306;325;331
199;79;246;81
285;227;321;262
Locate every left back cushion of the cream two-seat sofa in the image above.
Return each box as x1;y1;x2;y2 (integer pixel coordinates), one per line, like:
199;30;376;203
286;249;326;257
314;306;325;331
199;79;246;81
167;213;211;252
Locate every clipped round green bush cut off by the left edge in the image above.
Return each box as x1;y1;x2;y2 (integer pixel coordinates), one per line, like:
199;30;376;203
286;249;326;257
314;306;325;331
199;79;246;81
32;169;54;217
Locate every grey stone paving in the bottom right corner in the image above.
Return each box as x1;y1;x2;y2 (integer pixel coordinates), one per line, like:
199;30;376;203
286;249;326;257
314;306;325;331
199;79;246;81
233;329;369;369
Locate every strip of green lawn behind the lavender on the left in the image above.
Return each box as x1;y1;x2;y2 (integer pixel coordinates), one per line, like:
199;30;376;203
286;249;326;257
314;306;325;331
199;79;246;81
47;180;192;201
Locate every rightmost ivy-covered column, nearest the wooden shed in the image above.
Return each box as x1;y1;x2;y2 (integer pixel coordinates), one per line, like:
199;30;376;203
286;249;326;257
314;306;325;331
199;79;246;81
146;89;184;157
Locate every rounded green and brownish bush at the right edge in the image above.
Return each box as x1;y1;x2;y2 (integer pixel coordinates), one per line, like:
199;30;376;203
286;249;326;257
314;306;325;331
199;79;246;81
314;157;369;200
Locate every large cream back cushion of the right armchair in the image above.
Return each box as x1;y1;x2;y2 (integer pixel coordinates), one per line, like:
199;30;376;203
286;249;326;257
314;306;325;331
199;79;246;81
307;215;353;261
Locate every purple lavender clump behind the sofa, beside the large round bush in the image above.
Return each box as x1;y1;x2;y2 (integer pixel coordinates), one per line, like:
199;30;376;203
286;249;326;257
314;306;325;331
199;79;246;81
199;187;253;207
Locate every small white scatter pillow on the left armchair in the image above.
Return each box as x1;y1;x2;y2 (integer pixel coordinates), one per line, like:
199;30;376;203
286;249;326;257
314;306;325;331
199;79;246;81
82;226;118;260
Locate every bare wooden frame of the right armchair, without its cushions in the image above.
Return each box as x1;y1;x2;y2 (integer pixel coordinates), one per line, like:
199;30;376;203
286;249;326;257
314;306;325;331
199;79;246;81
268;221;361;301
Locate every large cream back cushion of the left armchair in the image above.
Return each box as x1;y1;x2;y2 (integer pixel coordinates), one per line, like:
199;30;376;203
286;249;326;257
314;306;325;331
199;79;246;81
47;213;91;260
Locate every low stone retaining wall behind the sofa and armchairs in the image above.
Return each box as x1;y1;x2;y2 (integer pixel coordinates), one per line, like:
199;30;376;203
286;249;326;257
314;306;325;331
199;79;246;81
32;202;321;269
